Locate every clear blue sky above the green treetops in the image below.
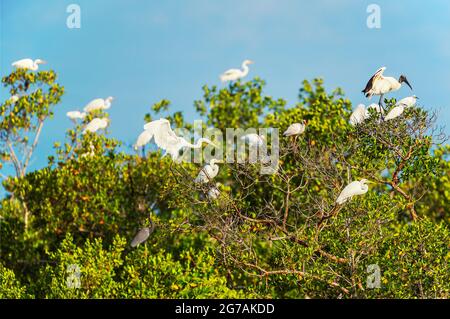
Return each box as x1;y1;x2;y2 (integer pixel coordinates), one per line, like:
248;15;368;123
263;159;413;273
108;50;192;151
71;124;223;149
0;0;450;178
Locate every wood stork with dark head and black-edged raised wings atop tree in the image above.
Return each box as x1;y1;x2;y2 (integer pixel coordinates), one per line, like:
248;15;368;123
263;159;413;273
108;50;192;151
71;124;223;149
362;66;412;115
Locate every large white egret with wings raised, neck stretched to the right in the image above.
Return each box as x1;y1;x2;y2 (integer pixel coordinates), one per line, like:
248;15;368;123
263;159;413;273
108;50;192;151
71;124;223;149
144;118;216;160
